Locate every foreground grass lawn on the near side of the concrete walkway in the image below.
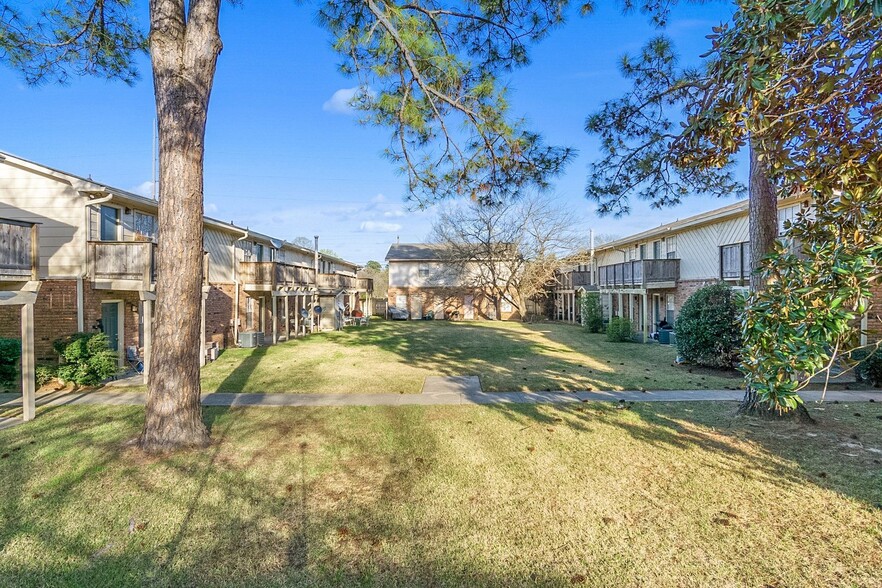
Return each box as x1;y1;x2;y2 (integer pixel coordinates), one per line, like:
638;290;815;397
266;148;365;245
0;403;882;588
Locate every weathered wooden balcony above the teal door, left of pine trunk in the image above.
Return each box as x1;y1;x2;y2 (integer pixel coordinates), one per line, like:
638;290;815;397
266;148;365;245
89;241;157;291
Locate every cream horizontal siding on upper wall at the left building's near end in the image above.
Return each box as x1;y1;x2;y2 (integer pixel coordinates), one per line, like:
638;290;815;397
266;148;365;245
0;163;86;278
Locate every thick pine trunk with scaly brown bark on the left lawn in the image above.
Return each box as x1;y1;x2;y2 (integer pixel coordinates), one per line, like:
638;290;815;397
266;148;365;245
139;0;221;451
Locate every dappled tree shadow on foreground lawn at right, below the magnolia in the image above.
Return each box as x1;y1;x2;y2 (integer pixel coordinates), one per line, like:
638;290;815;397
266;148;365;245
488;402;882;511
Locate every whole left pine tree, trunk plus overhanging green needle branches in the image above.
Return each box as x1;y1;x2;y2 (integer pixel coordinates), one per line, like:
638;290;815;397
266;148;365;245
0;0;570;450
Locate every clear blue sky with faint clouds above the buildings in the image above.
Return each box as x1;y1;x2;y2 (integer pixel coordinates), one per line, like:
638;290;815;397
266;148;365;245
0;0;747;263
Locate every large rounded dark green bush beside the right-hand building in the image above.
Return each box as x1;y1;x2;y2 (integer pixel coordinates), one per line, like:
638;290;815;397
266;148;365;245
674;283;743;368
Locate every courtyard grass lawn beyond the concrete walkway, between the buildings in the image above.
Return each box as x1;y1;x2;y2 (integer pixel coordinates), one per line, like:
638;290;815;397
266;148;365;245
192;321;741;394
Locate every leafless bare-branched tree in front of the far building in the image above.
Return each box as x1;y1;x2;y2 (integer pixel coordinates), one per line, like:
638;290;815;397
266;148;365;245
432;196;587;319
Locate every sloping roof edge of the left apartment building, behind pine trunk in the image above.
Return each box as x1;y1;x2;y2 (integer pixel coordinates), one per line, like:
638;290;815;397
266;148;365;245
0;151;358;267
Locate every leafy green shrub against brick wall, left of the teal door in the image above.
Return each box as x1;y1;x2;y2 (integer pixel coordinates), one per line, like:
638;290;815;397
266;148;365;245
53;333;119;386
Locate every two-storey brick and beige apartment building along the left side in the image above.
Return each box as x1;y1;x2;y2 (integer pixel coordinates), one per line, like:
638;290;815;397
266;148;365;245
0;152;372;378
